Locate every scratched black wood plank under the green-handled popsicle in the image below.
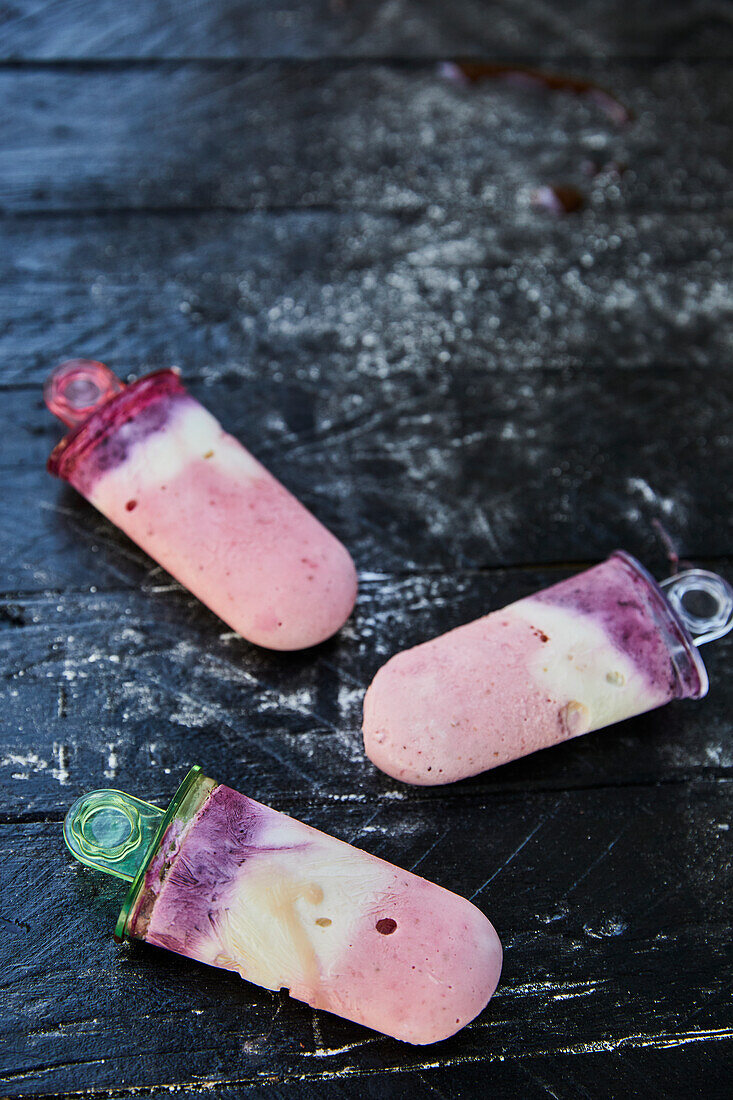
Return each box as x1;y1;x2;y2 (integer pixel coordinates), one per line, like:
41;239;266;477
0;783;733;1096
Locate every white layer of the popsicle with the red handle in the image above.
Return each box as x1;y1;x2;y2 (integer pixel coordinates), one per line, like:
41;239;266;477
89;399;263;515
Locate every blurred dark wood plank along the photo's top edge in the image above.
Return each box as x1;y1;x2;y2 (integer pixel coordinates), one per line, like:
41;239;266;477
0;0;733;59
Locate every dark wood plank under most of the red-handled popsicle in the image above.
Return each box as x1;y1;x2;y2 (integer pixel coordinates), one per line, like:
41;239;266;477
0;349;733;594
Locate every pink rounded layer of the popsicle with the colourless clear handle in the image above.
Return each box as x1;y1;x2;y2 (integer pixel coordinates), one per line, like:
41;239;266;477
364;615;556;785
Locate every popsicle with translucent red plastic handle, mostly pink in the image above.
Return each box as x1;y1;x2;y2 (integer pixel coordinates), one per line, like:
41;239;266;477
44;360;357;650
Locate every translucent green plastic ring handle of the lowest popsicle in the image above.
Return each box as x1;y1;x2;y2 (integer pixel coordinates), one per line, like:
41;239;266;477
64;791;165;882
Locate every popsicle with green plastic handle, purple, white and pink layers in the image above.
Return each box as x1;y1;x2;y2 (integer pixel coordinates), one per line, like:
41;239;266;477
64;768;502;1044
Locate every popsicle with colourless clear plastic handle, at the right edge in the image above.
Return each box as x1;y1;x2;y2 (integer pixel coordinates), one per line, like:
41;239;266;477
363;551;733;784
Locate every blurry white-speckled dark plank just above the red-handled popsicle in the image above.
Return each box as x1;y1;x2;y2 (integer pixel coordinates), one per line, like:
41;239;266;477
0;207;733;387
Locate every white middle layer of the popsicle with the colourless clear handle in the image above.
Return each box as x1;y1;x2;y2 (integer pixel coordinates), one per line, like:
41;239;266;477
506;596;667;734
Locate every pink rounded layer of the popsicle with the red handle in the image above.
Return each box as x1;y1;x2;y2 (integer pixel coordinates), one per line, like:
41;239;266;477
96;448;357;650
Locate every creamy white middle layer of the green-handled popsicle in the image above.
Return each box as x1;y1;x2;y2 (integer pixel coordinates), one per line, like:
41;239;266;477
192;815;390;991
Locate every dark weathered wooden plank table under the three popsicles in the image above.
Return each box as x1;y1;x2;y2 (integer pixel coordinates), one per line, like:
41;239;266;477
0;0;733;1100
